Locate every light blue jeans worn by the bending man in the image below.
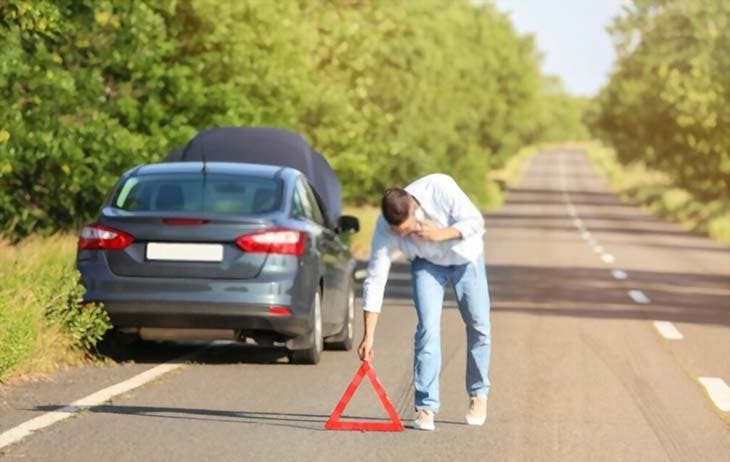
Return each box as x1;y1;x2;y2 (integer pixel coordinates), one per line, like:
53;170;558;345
411;257;492;412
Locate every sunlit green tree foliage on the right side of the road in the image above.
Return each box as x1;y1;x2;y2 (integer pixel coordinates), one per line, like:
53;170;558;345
590;0;730;200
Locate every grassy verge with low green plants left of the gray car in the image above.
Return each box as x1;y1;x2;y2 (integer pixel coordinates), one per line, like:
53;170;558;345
0;235;108;382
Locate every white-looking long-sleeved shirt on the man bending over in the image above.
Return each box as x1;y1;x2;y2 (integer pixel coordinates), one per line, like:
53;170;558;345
363;173;484;312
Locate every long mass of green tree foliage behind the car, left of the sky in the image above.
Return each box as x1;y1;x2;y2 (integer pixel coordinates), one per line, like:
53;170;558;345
0;0;580;239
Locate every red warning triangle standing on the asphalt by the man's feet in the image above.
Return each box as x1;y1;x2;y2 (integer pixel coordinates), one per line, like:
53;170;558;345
324;361;403;432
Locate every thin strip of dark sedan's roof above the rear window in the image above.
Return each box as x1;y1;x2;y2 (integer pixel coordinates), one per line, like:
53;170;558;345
130;161;301;178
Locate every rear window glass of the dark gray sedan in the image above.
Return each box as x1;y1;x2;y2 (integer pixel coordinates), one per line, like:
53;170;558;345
112;173;282;215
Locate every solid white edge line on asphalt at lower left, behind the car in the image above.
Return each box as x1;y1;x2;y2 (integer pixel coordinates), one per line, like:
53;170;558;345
0;350;199;449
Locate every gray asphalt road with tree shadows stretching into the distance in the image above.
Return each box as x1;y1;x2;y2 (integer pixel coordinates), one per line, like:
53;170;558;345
0;152;730;462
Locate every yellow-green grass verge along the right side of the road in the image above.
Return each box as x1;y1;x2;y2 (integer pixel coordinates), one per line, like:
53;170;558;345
585;143;730;246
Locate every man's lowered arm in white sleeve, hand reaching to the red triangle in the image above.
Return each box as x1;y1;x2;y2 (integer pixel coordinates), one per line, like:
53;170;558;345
358;216;393;361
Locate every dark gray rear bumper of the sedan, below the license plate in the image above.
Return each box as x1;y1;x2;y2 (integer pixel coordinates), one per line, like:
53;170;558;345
78;253;314;339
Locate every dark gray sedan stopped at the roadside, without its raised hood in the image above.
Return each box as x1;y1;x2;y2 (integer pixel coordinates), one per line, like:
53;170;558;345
77;162;359;364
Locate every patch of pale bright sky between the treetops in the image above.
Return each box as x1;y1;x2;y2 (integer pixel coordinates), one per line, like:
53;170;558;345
493;0;626;96
